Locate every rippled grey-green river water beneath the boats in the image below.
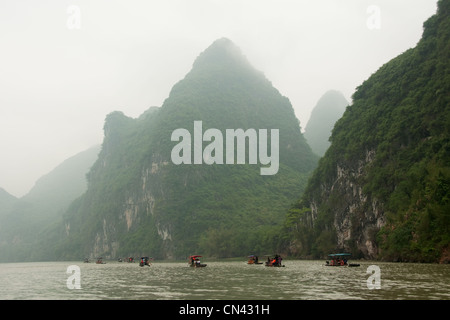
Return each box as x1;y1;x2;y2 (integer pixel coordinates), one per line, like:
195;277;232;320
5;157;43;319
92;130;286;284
0;260;450;300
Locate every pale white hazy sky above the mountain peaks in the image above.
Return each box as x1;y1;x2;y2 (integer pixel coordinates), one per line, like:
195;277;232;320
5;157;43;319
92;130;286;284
0;0;437;197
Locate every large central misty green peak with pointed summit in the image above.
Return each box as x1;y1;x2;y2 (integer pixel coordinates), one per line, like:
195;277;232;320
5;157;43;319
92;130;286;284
48;39;317;259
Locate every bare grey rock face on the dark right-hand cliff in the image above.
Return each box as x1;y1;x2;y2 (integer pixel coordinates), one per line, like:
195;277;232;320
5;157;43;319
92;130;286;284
303;150;385;259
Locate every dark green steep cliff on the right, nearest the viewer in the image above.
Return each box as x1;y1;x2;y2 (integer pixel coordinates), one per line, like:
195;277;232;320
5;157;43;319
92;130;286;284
286;0;450;261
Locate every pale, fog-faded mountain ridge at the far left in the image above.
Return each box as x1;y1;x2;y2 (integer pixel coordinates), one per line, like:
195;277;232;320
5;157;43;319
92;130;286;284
0;146;100;261
